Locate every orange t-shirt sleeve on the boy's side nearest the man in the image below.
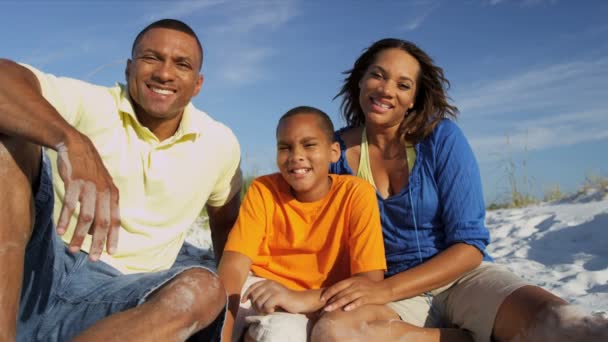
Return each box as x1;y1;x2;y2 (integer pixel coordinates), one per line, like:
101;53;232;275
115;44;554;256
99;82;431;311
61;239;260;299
224;180;268;260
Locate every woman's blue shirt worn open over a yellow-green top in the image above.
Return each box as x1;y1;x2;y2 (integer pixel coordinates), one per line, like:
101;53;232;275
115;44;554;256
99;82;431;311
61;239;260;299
330;119;492;277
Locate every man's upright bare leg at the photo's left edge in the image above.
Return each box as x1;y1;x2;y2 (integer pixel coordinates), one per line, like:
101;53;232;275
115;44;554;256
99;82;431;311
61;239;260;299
0;134;42;341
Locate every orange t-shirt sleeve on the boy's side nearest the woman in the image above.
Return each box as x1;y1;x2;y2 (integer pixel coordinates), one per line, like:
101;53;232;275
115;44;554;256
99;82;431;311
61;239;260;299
348;181;386;274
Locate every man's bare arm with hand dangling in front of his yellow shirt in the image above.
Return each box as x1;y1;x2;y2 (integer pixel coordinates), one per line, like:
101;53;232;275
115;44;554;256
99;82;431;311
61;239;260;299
0;59;120;260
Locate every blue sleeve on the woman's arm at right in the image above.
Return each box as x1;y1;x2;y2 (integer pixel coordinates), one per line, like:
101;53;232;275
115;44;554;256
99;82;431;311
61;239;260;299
434;120;490;255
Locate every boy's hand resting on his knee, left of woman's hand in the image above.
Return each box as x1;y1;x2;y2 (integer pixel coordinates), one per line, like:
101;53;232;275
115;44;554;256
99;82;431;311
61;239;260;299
241;280;303;315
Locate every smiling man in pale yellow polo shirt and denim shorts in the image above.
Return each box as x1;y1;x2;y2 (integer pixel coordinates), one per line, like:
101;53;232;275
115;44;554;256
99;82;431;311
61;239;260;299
0;19;241;341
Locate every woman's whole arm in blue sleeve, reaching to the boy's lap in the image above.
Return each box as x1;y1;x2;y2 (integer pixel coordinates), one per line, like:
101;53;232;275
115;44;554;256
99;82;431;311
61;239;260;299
323;122;489;311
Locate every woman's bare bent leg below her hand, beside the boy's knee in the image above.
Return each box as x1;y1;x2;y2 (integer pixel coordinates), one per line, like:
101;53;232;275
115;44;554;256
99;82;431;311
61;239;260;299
310;305;473;342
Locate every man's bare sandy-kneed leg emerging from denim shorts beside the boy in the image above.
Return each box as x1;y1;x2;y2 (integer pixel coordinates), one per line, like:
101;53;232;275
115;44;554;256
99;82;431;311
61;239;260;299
74;269;226;341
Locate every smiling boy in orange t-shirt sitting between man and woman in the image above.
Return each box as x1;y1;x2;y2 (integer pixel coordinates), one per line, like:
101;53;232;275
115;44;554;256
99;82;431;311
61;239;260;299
219;107;386;341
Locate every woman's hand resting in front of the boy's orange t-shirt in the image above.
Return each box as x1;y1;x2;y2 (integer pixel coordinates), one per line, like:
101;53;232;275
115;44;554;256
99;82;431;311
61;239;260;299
321;276;391;311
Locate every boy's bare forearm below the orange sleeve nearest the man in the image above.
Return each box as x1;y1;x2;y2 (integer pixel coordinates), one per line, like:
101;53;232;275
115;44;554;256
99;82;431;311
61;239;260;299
218;251;251;341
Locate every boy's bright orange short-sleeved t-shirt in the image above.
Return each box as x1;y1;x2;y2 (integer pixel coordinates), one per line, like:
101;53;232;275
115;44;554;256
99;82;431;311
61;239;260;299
224;173;386;290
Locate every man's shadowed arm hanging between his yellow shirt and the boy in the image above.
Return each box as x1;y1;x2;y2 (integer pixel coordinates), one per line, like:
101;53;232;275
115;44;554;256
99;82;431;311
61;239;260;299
207;192;241;262
